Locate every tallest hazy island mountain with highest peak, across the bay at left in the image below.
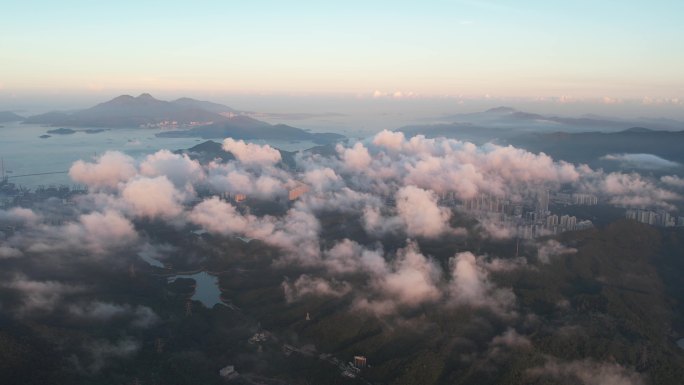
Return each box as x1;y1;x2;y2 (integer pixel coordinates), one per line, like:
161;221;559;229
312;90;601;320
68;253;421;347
24;94;229;128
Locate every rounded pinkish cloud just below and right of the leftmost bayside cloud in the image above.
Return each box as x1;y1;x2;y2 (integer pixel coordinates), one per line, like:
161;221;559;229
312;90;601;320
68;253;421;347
121;175;184;218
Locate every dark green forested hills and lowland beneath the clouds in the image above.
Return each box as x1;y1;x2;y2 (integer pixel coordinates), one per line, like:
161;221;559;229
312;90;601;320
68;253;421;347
0;204;684;385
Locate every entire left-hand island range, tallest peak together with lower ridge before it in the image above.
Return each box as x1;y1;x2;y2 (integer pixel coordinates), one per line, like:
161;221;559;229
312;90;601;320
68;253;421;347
22;94;344;143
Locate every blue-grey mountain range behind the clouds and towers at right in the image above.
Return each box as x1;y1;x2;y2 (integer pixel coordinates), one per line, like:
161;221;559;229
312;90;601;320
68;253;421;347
397;107;684;169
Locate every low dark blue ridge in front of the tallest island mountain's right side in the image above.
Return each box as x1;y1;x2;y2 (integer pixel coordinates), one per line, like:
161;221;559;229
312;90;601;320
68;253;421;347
157;116;344;144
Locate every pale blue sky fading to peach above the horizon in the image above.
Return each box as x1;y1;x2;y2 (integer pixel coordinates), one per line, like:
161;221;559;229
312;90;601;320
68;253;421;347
0;0;684;98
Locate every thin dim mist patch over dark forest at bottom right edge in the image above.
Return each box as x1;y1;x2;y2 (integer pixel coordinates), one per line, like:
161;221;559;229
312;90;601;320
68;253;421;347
527;358;646;385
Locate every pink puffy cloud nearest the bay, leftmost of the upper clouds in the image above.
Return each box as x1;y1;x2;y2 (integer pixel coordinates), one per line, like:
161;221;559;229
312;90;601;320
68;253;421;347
69;151;138;189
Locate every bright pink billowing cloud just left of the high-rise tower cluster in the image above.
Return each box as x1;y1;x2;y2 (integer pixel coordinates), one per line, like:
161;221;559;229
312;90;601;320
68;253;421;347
396;186;451;238
